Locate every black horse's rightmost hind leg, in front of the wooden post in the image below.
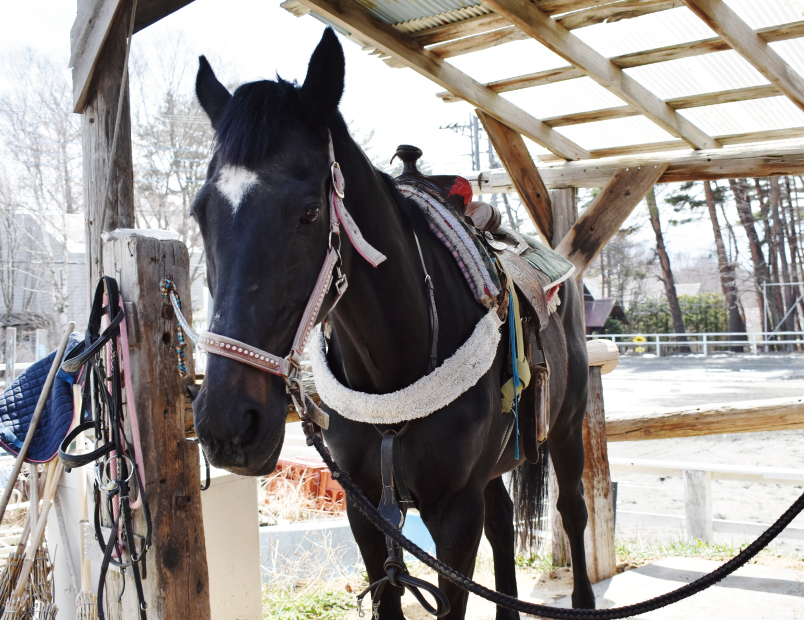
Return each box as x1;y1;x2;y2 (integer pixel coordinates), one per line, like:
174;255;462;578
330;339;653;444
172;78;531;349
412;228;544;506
547;426;595;609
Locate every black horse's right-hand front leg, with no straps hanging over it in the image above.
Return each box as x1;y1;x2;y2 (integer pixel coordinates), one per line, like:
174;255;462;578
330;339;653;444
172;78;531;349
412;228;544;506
421;487;483;620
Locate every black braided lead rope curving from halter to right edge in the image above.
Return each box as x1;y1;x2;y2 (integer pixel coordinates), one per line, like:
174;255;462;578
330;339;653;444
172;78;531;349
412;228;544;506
303;423;804;620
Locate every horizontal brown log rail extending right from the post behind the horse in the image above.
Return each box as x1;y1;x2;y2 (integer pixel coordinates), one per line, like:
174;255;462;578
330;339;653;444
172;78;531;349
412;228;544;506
606;398;804;441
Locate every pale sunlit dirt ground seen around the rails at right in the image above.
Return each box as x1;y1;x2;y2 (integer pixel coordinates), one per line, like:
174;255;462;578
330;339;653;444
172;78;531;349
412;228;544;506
603;355;804;557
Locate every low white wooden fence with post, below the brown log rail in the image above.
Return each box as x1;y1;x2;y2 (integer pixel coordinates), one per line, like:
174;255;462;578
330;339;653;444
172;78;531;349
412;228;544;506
609;457;804;543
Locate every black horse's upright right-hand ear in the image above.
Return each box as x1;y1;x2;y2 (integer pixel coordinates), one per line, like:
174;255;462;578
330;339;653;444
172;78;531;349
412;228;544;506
300;28;346;120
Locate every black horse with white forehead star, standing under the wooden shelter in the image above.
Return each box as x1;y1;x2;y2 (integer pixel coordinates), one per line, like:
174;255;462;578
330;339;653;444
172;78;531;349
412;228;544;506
192;29;594;618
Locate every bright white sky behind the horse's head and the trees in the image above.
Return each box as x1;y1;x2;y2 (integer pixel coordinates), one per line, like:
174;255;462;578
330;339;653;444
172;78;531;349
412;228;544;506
0;0;752;270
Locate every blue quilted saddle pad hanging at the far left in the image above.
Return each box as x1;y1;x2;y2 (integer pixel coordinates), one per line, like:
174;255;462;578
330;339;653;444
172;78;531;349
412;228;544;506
0;332;84;463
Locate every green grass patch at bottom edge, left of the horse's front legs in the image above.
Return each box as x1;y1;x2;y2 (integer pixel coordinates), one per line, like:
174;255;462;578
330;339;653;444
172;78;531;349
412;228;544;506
262;585;357;620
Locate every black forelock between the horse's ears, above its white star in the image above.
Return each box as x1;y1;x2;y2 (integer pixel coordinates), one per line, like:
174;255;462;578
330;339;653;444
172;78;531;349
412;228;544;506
215;76;304;169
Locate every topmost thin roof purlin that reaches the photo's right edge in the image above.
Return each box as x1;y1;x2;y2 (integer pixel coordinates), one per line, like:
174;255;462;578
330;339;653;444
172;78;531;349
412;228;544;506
436;21;804;103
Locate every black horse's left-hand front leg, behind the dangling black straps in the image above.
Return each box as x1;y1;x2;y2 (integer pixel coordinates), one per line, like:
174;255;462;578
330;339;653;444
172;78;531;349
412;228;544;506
346;496;405;620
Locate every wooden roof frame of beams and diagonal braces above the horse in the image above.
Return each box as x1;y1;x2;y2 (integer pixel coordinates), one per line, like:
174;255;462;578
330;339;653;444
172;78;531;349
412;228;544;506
282;0;804;256
